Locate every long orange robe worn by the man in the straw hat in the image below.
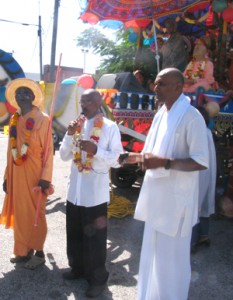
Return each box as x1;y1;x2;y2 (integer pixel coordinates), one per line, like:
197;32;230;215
0;109;53;256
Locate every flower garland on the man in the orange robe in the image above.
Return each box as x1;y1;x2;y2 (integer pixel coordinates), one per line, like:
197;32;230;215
9;108;36;166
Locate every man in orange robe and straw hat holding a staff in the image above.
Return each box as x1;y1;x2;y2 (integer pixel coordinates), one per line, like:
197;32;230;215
0;78;53;269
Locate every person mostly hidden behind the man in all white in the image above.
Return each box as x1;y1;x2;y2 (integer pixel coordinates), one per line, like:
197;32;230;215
191;107;217;253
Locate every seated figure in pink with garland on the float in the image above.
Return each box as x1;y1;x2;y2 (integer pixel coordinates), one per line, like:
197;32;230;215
183;40;215;93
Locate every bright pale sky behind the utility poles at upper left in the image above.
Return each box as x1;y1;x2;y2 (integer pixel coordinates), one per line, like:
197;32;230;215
0;0;102;73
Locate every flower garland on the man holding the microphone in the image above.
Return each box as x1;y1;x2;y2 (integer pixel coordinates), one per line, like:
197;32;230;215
73;114;103;174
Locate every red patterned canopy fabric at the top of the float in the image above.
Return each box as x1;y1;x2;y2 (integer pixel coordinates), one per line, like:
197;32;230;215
80;0;211;24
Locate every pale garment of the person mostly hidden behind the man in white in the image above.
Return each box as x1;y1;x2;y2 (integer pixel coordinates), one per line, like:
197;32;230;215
198;128;217;217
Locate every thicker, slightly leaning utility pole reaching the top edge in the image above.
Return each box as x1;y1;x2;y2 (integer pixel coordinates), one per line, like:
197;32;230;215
49;0;60;82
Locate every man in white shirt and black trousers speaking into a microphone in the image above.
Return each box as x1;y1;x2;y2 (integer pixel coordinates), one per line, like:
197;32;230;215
59;89;123;298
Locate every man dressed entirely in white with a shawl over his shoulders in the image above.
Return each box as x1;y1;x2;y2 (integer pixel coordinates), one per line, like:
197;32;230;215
123;68;208;300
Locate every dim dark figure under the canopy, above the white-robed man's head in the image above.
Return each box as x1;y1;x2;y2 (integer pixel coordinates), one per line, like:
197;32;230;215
160;18;188;72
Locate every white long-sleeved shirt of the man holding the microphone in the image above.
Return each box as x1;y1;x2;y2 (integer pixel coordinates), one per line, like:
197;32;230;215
59;118;123;207
